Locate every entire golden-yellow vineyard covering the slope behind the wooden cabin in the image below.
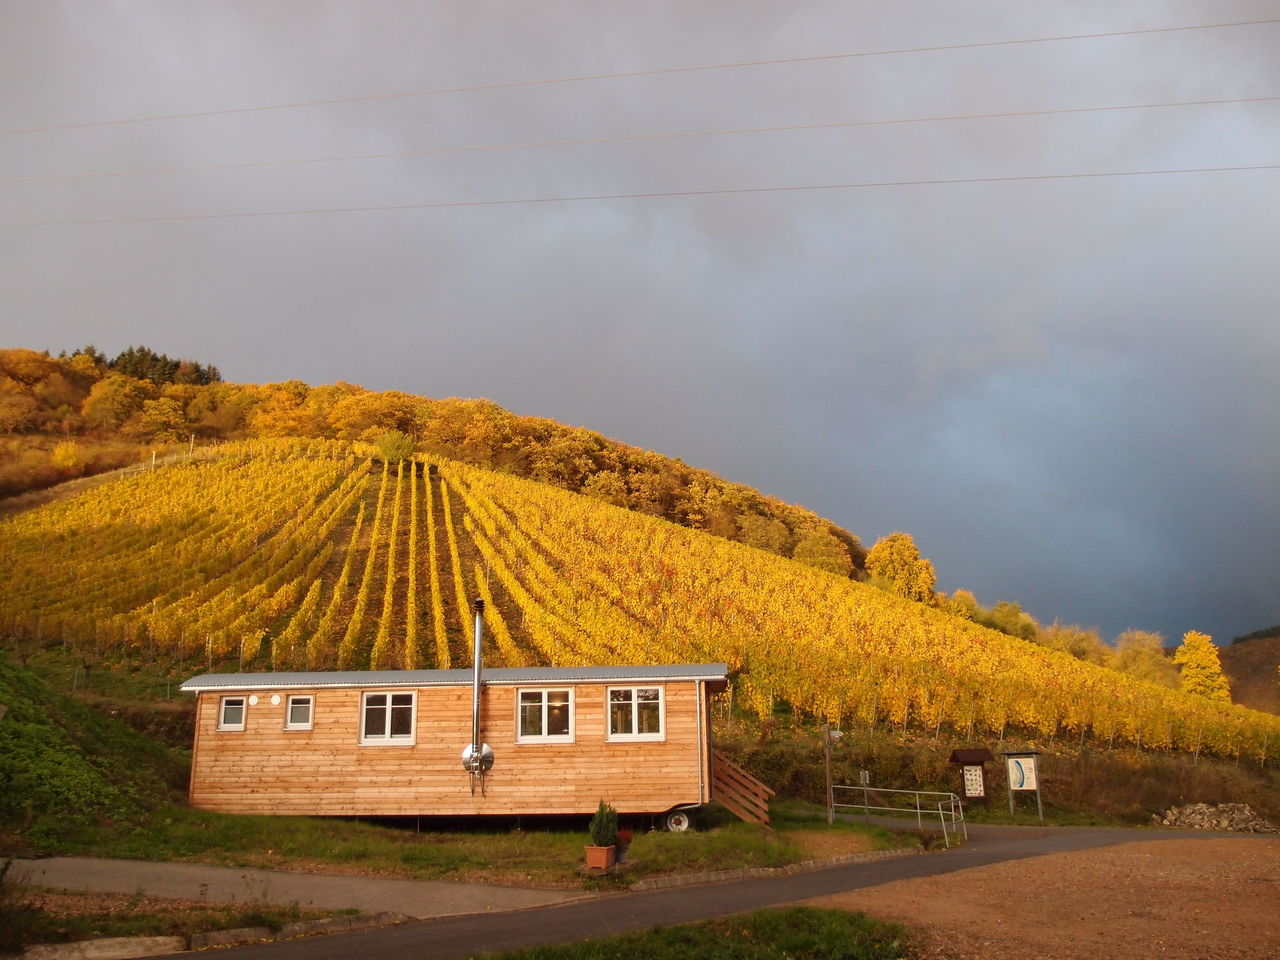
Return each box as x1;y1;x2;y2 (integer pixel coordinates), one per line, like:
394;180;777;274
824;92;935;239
0;440;1280;763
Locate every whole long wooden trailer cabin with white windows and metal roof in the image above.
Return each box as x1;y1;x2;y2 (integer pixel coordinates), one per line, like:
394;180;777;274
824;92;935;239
182;663;727;824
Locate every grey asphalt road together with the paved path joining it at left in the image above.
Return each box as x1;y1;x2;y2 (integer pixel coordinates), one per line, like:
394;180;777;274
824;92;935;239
20;824;1244;960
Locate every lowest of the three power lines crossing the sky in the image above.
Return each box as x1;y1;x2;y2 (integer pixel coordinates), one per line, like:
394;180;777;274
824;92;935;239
12;163;1280;228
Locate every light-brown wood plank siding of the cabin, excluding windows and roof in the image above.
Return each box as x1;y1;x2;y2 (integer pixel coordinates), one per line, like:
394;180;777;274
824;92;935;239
191;680;710;815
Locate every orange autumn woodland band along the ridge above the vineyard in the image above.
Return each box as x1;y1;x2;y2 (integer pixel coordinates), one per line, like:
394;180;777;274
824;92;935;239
0;347;865;576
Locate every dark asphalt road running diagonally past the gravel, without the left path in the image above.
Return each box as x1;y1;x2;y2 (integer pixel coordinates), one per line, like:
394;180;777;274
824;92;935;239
157;826;1247;960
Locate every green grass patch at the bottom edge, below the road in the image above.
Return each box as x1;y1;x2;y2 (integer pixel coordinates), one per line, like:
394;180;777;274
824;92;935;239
473;908;910;960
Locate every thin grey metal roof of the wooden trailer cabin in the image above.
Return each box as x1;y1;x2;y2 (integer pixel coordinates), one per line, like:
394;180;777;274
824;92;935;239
178;663;728;694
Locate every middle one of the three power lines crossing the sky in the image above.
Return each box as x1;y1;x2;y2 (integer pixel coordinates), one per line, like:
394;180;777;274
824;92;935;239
0;96;1280;186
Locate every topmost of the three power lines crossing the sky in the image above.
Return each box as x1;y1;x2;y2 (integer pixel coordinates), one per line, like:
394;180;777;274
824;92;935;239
0;17;1280;134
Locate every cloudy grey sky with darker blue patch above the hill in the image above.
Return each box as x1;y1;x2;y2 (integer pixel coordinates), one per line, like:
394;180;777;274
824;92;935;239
0;0;1280;641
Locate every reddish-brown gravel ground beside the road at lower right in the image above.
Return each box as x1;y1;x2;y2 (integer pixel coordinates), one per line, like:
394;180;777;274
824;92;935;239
810;837;1280;960
